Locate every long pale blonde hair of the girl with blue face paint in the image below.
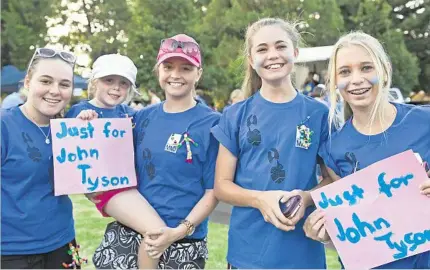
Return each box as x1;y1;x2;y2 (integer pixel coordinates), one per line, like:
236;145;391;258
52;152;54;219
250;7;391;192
326;31;392;131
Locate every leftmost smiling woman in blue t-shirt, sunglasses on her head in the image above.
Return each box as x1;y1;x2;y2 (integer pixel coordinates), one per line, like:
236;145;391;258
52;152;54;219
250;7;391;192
1;48;79;269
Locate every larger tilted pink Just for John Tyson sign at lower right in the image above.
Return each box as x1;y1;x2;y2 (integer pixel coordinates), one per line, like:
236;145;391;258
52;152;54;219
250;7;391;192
311;150;430;269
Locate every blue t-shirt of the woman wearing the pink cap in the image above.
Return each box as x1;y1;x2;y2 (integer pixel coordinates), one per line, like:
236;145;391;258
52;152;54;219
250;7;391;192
133;102;220;239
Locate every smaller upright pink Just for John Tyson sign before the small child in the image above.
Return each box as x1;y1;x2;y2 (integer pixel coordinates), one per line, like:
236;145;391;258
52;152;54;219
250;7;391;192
51;118;137;196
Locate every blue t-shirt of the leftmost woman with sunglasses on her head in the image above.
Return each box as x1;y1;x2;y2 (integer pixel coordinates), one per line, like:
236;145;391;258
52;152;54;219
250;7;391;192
1;107;75;255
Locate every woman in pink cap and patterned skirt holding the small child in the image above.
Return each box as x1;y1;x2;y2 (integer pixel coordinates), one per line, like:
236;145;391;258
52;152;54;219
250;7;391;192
88;34;220;269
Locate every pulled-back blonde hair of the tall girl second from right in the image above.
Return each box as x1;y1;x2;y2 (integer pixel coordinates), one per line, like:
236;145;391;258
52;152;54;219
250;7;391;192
242;18;300;97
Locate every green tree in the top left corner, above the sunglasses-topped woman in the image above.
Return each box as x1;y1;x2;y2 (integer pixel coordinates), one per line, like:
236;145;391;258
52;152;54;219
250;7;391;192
1;0;57;69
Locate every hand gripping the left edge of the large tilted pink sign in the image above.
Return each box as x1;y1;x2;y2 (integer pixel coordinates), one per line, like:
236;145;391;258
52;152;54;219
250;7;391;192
303;210;330;243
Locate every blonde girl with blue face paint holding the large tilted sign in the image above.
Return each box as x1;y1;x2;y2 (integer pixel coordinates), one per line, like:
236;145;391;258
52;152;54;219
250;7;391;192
304;32;430;269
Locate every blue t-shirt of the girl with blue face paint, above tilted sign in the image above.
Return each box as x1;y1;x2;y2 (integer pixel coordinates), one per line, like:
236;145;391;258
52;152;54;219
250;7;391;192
320;103;430;269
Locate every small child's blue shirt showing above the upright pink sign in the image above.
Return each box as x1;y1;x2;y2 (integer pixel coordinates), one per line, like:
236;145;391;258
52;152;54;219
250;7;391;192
65;100;136;118
